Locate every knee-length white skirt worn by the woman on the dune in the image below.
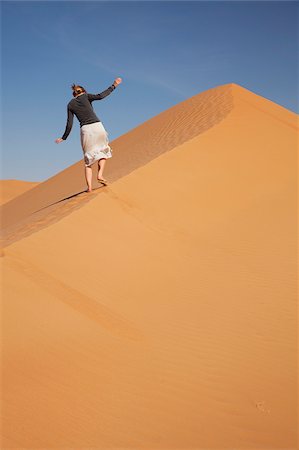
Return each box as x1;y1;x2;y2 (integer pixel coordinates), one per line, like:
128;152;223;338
80;122;112;167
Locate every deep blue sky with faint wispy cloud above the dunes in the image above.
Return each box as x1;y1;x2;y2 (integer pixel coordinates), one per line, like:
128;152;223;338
1;1;299;181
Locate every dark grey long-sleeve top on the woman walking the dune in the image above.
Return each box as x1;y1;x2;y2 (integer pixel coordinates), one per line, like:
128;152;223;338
61;84;116;141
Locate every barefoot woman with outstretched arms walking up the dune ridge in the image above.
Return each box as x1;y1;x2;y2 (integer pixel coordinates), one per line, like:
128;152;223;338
55;78;122;192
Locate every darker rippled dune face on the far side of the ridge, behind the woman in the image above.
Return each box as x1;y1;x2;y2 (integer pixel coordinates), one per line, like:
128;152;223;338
2;85;233;245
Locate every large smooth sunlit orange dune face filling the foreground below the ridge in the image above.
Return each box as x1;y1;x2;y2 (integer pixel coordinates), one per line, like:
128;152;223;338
1;85;298;450
